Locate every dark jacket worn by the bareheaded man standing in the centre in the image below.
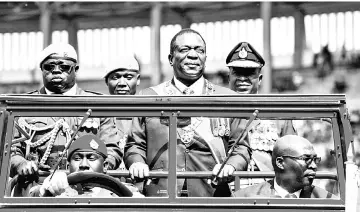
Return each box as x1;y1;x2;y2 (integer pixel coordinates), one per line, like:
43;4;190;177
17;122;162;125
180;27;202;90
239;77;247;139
124;78;250;196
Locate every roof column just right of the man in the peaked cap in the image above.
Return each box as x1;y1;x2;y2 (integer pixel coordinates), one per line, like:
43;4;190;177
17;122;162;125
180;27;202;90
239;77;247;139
260;2;272;94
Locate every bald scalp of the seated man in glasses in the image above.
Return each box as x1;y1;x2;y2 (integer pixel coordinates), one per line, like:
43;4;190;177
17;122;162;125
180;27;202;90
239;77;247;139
272;135;314;169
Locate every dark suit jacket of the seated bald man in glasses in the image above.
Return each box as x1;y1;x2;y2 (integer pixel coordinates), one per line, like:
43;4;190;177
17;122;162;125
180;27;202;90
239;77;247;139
233;180;336;198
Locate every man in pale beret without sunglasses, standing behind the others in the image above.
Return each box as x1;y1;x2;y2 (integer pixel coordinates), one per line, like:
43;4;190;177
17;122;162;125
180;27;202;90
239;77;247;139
104;55;140;159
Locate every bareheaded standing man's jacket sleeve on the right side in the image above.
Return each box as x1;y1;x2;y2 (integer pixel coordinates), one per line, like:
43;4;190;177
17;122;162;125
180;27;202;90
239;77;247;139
227;118;251;171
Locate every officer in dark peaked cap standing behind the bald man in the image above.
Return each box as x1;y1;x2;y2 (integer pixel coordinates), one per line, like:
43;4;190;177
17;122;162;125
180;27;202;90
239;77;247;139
226;42;296;184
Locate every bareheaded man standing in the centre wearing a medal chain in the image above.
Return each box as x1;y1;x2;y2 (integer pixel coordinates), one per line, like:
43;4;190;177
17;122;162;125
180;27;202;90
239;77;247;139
124;29;250;197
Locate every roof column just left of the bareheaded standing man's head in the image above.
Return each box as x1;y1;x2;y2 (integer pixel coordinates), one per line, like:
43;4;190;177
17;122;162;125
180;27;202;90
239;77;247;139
150;2;164;85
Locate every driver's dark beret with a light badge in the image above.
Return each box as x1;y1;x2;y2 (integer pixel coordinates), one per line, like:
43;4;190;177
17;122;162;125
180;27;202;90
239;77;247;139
67;134;107;161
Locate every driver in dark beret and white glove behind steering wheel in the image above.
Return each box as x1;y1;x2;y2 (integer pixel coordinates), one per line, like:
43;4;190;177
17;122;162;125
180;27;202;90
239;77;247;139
29;134;143;197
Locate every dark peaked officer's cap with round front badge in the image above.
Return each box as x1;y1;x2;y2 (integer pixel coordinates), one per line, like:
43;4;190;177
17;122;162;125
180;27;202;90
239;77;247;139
226;42;265;68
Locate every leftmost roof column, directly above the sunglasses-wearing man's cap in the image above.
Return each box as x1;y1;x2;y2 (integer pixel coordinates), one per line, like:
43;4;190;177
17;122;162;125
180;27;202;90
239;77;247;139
38;2;52;48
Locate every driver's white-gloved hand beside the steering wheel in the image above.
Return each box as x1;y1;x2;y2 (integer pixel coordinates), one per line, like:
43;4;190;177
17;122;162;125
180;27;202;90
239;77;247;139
40;171;71;197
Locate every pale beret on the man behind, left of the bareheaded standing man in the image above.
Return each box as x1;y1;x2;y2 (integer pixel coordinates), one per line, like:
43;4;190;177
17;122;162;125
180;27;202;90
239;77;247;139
104;55;140;79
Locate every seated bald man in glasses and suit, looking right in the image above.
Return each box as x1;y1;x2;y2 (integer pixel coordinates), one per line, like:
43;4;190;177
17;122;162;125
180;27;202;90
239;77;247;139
234;135;335;198
